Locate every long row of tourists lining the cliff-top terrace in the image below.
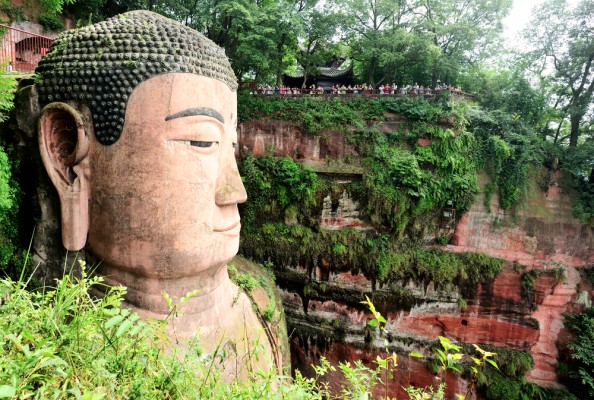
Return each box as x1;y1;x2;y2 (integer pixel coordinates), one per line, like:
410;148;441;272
252;82;462;95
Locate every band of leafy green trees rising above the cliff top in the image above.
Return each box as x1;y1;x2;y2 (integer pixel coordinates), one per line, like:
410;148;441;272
10;0;594;225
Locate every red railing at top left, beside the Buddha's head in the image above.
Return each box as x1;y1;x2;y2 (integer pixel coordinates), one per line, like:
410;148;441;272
0;24;53;72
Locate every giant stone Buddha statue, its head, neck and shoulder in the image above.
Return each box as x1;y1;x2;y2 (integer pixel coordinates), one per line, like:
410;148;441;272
35;11;282;374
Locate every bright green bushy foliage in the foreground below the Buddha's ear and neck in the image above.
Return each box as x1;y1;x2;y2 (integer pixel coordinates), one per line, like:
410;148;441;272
0;264;365;400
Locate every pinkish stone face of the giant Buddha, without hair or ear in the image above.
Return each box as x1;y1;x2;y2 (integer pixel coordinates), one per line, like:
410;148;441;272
88;73;246;312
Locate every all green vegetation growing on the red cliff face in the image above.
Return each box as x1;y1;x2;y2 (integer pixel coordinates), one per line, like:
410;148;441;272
235;96;584;399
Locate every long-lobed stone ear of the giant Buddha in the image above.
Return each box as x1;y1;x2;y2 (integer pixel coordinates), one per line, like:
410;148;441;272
39;103;91;251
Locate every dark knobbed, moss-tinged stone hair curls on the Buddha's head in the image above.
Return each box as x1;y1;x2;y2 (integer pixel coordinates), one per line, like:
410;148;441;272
36;11;237;145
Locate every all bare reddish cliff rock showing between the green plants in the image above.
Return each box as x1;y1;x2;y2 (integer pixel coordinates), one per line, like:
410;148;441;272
239;116;594;397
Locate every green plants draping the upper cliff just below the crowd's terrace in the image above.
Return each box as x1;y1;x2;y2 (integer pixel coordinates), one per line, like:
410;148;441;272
238;94;555;219
